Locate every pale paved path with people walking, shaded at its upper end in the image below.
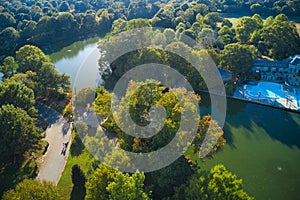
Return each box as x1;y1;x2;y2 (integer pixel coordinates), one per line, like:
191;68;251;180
36;105;72;185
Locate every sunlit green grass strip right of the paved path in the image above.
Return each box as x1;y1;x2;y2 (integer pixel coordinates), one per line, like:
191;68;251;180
58;133;94;199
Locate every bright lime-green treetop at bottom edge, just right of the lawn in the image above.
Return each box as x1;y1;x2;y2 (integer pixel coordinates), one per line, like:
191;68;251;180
106;171;150;200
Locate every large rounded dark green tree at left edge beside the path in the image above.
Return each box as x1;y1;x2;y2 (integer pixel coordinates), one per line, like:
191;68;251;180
0;105;42;162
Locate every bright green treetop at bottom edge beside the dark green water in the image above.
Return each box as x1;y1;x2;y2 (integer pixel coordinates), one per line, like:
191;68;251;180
173;165;253;200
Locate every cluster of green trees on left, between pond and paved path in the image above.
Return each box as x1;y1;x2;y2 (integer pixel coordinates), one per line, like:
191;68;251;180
0;45;70;164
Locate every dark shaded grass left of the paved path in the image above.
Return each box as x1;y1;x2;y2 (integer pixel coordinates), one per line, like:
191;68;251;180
0;140;46;199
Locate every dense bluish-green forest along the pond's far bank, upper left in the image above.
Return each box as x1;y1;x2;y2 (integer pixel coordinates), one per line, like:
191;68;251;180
0;0;164;59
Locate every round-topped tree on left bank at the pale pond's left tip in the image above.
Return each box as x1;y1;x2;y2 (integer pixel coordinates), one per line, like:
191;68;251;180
16;45;50;73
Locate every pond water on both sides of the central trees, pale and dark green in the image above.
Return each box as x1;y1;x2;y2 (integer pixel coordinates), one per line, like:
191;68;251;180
50;38;300;200
